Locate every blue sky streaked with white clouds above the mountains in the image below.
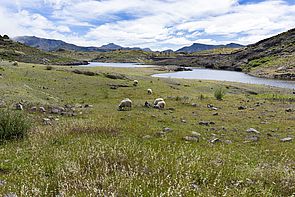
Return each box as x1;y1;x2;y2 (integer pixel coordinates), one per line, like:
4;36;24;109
0;0;295;50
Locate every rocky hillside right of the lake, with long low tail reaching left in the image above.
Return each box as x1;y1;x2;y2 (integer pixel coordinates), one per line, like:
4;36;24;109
154;29;295;80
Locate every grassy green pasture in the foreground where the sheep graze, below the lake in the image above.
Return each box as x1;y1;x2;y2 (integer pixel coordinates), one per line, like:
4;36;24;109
0;63;295;196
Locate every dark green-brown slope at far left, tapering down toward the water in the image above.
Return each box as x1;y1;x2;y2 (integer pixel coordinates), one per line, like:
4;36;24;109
0;37;82;64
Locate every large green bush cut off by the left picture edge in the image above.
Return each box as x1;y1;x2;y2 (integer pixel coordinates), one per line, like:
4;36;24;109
0;110;31;142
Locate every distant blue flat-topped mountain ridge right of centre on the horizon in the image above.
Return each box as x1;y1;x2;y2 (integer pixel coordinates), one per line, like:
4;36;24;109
176;43;244;53
